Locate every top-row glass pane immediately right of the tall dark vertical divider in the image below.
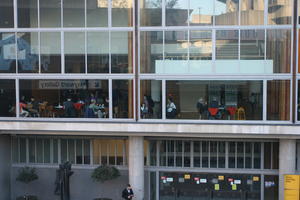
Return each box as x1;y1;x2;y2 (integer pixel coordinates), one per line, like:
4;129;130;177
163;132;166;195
140;0;162;26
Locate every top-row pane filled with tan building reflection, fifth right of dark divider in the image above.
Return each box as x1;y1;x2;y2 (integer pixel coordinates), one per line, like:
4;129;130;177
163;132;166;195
241;0;265;25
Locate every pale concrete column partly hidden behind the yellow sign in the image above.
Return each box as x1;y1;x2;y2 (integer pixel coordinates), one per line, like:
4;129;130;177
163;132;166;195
279;139;296;199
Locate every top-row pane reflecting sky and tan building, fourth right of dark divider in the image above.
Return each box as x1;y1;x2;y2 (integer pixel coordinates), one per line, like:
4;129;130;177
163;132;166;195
215;0;239;25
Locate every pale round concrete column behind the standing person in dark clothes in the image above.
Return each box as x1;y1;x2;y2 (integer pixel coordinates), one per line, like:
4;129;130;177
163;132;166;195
128;136;144;200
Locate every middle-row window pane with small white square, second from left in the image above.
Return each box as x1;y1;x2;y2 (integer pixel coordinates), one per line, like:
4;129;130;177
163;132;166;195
17;32;39;73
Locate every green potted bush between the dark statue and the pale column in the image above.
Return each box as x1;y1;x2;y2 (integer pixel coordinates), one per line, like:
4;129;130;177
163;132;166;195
91;165;120;200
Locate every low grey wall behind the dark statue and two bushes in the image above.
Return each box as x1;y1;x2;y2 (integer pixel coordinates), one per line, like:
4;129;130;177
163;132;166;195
10;167;128;200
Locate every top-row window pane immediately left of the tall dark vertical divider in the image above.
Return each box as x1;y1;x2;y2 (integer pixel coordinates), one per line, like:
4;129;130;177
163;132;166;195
111;0;133;27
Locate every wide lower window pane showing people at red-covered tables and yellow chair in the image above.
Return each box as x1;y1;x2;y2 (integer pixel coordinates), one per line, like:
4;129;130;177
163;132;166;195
166;81;263;120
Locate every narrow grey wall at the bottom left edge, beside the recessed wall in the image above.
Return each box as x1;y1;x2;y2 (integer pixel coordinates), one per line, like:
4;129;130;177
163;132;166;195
0;136;11;200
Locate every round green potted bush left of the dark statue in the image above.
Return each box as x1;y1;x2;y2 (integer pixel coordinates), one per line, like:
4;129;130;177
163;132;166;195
16;167;39;200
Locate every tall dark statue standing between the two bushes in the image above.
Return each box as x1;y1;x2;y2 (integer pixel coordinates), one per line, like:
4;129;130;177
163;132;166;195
54;162;74;200
